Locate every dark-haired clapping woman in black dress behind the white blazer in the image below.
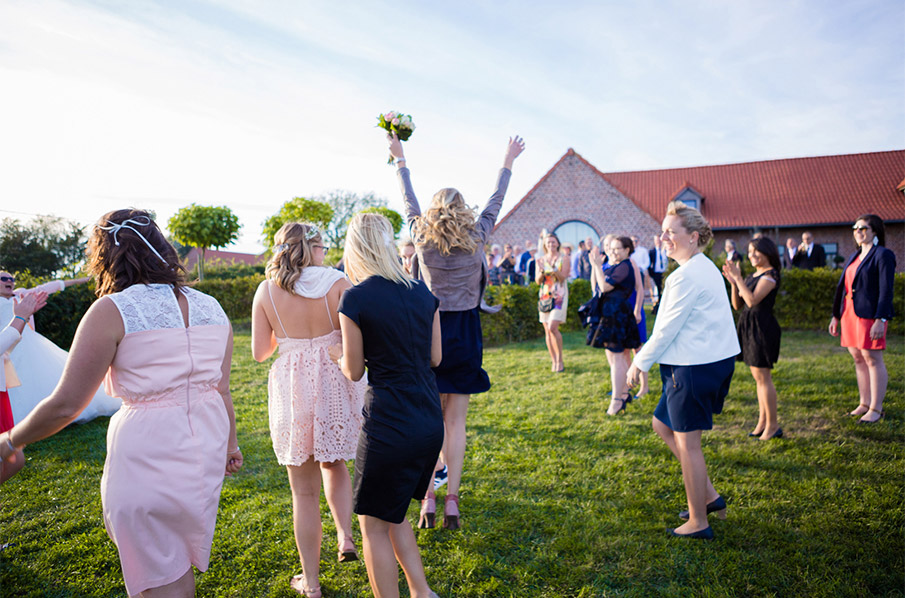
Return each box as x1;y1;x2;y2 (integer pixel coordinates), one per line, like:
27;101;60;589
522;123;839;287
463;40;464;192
723;237;782;440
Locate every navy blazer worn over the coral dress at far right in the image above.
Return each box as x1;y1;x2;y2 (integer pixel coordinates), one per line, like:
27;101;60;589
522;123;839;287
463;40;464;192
833;246;896;320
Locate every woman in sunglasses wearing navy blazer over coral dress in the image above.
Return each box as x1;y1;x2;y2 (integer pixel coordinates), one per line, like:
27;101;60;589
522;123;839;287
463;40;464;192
830;214;896;424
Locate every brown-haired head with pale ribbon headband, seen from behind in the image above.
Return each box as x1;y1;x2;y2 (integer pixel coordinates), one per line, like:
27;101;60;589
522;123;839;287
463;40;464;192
87;208;185;297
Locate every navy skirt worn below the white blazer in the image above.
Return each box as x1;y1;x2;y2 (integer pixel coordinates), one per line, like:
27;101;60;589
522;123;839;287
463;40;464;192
654;356;735;432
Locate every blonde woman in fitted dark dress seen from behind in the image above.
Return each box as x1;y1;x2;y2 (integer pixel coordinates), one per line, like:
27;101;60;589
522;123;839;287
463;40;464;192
330;214;443;598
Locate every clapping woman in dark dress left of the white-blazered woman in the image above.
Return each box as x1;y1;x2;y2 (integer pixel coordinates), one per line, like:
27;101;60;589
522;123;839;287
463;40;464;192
589;237;641;415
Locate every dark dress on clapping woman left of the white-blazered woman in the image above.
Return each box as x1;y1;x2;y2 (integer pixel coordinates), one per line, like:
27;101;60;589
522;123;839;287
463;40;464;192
595;260;641;353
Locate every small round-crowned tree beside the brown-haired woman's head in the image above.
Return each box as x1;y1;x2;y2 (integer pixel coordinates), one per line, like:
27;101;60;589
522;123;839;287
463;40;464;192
167;203;242;280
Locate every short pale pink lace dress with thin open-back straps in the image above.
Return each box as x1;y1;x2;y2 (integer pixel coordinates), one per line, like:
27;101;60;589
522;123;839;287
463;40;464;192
267;282;367;465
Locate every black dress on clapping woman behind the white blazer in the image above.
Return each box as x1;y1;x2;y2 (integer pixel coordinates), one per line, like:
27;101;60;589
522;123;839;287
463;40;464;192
737;270;782;369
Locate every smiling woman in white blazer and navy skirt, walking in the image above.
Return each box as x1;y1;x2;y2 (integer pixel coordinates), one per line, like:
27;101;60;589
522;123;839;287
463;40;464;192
626;201;740;540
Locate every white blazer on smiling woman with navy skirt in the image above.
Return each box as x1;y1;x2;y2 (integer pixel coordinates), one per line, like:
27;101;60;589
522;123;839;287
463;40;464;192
633;253;741;372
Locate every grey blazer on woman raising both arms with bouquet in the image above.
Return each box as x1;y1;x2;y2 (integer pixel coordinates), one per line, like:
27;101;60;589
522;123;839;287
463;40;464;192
397;167;512;311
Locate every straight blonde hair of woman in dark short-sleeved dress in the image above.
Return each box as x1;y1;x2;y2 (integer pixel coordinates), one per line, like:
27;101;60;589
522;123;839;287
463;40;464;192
343;213;412;288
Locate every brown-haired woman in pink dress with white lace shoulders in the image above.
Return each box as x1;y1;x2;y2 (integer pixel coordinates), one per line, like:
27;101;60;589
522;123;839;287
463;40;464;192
0;209;242;597
